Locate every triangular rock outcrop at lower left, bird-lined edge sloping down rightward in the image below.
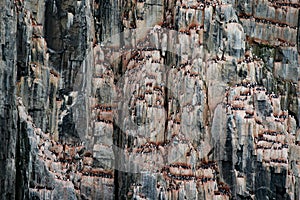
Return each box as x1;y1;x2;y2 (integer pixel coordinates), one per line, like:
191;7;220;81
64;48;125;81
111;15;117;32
17;100;114;199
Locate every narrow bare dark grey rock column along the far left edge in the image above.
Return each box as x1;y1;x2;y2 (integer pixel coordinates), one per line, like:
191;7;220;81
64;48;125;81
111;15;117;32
0;1;18;199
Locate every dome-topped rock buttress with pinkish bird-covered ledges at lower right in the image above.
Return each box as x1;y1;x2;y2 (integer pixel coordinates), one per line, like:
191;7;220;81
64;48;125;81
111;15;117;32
212;83;298;199
